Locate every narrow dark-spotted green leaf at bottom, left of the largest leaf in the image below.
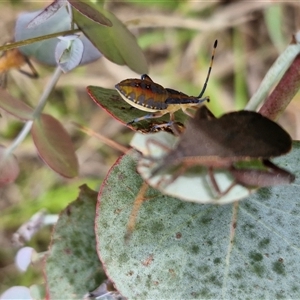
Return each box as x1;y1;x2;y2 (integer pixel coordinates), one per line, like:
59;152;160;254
45;185;104;299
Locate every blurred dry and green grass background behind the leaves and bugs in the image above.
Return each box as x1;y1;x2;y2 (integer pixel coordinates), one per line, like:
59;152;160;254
0;0;300;294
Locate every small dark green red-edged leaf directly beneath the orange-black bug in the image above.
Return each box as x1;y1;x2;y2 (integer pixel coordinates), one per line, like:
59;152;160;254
87;86;188;132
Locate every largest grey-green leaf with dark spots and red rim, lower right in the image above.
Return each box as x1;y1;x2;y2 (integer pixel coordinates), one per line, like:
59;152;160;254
96;142;300;299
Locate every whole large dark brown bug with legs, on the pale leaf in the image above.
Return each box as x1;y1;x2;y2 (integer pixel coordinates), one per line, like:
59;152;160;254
152;106;295;197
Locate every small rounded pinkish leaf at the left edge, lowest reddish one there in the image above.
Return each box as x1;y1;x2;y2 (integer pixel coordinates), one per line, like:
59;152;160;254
0;146;20;187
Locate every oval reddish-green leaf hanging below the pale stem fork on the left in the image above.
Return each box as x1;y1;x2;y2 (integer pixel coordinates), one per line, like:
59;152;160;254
31;114;78;178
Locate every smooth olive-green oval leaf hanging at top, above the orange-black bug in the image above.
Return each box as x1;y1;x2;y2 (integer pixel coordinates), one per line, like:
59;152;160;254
73;3;148;74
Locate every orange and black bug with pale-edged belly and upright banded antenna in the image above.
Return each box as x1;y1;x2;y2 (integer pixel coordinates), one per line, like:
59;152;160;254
115;40;218;126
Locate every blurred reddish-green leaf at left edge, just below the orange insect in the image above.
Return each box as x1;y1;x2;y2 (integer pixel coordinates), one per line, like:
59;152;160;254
0;89;33;120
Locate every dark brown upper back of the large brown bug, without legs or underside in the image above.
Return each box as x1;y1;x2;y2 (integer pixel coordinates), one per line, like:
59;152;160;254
158;107;292;167
